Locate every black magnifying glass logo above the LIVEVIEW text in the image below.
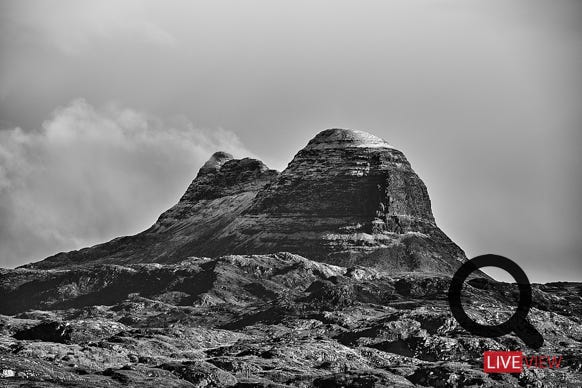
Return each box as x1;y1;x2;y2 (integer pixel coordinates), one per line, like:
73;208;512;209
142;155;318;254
448;255;544;349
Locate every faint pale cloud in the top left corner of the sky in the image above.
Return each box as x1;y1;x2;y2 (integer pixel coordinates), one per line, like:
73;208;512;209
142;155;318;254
1;0;176;54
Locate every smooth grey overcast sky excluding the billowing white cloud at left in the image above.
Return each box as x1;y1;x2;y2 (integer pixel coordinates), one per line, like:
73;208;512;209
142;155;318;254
0;0;582;281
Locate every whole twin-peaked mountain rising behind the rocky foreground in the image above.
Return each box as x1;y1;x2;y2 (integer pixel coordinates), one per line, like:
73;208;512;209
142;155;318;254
28;129;465;273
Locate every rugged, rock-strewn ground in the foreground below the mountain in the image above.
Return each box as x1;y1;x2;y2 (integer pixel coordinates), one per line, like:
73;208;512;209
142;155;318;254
0;253;582;387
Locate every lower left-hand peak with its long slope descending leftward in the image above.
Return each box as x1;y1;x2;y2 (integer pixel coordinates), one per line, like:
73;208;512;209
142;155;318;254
25;152;278;268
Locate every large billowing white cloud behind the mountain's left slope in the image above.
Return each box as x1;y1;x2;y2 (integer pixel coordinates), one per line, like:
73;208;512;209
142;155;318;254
0;99;250;266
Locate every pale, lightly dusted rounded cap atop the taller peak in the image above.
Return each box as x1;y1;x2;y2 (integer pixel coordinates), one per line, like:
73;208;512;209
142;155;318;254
305;128;394;150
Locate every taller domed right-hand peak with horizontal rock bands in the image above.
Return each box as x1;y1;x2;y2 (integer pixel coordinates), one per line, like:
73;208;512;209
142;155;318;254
203;129;465;272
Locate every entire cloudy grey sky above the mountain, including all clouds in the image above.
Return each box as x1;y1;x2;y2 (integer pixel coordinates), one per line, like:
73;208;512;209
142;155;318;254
0;0;582;282
